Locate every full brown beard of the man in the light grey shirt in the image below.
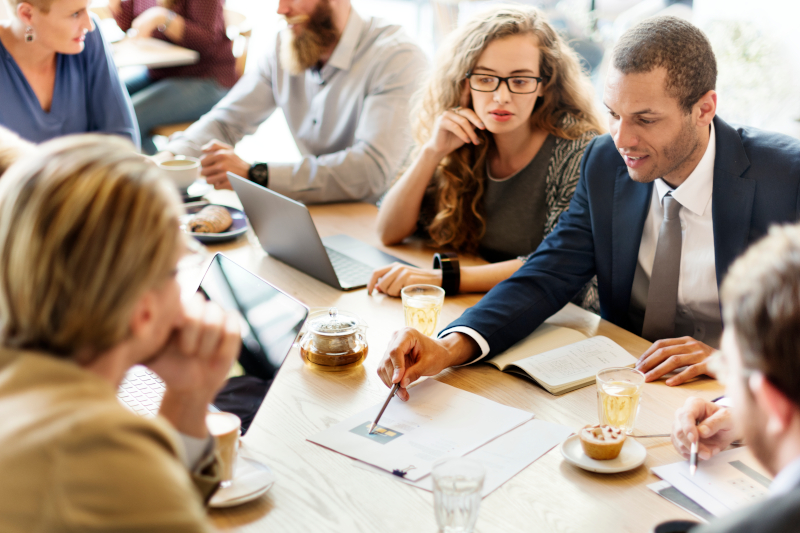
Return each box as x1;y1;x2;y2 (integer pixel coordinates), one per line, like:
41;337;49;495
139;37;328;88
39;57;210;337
280;0;339;76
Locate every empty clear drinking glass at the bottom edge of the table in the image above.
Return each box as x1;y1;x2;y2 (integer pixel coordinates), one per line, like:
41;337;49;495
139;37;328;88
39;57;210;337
431;458;486;533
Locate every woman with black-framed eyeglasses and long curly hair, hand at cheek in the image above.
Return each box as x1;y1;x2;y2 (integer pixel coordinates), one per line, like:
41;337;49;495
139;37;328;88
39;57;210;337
368;6;602;308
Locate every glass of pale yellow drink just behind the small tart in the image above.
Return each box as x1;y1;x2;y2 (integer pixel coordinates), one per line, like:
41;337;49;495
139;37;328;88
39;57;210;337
597;367;644;435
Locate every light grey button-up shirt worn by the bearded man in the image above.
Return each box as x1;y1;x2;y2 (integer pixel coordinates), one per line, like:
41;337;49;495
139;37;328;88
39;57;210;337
166;8;427;203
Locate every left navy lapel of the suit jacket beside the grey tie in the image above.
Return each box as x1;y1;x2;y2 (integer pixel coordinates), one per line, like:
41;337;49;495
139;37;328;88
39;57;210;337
611;166;653;323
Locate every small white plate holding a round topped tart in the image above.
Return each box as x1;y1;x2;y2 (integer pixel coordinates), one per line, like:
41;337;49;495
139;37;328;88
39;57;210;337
561;425;647;474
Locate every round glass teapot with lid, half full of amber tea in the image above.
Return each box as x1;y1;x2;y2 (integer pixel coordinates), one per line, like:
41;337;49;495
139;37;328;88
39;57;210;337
300;307;369;372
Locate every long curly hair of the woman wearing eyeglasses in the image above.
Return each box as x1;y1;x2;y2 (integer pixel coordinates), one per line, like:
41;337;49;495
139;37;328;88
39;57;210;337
411;5;603;252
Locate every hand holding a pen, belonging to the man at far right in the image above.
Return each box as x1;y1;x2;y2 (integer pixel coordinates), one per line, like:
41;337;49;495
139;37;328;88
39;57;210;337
672;397;738;468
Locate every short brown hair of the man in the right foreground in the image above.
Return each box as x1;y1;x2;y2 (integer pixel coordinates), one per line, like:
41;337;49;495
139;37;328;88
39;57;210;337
721;225;800;406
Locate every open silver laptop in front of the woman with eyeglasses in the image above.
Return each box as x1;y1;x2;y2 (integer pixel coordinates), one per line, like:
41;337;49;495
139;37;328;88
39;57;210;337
228;172;411;290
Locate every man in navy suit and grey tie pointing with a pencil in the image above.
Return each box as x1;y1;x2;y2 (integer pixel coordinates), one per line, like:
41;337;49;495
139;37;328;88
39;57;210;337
378;17;800;400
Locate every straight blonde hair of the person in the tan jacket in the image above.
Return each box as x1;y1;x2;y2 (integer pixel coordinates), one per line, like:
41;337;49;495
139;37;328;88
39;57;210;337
0;135;182;357
